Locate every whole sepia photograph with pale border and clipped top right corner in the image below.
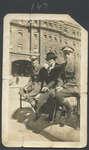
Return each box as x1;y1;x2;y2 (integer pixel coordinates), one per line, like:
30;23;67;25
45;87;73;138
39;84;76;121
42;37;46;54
2;14;88;148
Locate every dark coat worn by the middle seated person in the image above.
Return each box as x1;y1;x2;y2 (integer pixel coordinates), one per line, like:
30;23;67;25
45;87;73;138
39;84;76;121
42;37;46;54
39;63;66;88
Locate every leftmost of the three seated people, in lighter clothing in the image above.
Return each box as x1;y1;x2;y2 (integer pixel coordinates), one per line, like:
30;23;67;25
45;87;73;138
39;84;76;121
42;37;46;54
19;56;41;106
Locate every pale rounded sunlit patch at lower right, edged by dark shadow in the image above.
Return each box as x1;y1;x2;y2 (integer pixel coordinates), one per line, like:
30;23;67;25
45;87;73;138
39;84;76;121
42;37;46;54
43;125;80;142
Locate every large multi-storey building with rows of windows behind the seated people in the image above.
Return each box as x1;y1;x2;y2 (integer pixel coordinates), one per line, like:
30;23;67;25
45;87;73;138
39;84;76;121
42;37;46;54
9;20;81;75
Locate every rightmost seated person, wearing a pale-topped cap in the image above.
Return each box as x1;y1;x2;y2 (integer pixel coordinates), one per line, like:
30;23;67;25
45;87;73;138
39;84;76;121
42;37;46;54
55;47;80;119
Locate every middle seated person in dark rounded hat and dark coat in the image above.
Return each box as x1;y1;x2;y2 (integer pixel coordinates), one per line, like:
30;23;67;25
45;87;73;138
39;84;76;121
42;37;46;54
36;52;65;121
